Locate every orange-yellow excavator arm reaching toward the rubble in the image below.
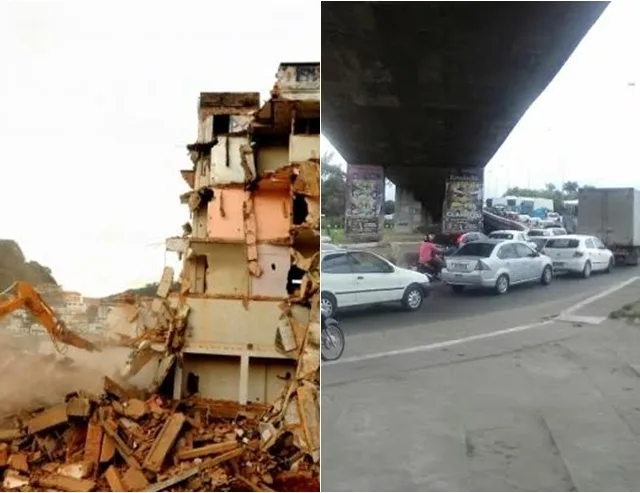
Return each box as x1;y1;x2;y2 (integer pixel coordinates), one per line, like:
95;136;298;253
0;281;100;351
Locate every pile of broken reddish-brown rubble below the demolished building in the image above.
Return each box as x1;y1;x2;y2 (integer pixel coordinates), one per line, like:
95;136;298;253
0;378;319;491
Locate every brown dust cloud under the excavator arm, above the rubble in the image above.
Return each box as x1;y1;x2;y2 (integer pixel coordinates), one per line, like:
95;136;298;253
0;334;129;416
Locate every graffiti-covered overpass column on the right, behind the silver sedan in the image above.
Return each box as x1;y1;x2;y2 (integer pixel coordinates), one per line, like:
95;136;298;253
442;170;483;232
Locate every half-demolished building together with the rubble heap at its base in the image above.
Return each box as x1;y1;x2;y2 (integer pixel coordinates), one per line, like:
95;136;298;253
0;63;320;491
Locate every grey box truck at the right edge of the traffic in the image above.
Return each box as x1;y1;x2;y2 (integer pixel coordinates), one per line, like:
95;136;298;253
577;188;640;265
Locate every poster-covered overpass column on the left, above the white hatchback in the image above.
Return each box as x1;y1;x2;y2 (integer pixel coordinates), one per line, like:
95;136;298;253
345;164;384;243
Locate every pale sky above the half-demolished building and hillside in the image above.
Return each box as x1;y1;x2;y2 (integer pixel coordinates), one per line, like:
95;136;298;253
0;0;320;296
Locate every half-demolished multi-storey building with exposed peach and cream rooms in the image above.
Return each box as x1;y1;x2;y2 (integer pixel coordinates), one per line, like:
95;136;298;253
167;64;320;403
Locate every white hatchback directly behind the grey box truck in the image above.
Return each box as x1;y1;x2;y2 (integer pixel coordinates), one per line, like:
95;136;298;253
542;235;615;278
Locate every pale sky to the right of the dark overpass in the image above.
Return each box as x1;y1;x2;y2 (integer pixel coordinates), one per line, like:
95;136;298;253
325;0;640;197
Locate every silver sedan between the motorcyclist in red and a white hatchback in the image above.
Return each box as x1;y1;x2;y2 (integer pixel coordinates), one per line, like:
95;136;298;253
441;239;553;294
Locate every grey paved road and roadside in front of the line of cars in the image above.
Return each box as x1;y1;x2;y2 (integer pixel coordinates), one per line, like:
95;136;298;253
322;268;640;491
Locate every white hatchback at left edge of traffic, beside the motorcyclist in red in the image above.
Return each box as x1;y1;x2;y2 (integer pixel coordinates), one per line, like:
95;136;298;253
320;249;430;317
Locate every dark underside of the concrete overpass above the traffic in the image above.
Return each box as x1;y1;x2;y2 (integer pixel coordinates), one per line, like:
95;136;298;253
322;2;613;234
